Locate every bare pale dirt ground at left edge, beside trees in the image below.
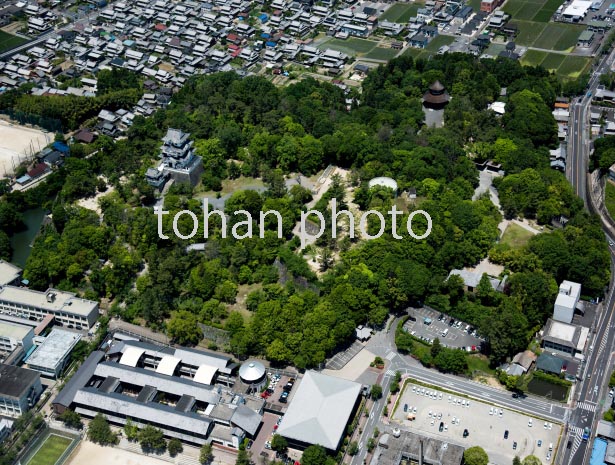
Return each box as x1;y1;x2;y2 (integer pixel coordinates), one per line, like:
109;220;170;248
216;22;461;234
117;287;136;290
0;120;53;178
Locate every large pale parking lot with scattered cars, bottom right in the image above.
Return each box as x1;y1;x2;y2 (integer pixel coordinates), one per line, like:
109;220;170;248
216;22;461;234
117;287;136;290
393;383;561;465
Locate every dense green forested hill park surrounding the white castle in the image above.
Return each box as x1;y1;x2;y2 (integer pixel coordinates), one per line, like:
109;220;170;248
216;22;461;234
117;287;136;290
0;54;609;368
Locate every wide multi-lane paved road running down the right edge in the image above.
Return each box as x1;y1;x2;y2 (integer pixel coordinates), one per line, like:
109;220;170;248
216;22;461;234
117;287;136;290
558;46;615;465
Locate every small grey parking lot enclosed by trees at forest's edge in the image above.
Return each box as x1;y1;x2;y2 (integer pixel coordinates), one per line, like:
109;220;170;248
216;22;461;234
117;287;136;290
404;308;482;350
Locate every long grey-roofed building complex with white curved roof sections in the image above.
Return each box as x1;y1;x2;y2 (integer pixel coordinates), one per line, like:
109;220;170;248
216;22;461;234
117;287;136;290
53;340;264;448
